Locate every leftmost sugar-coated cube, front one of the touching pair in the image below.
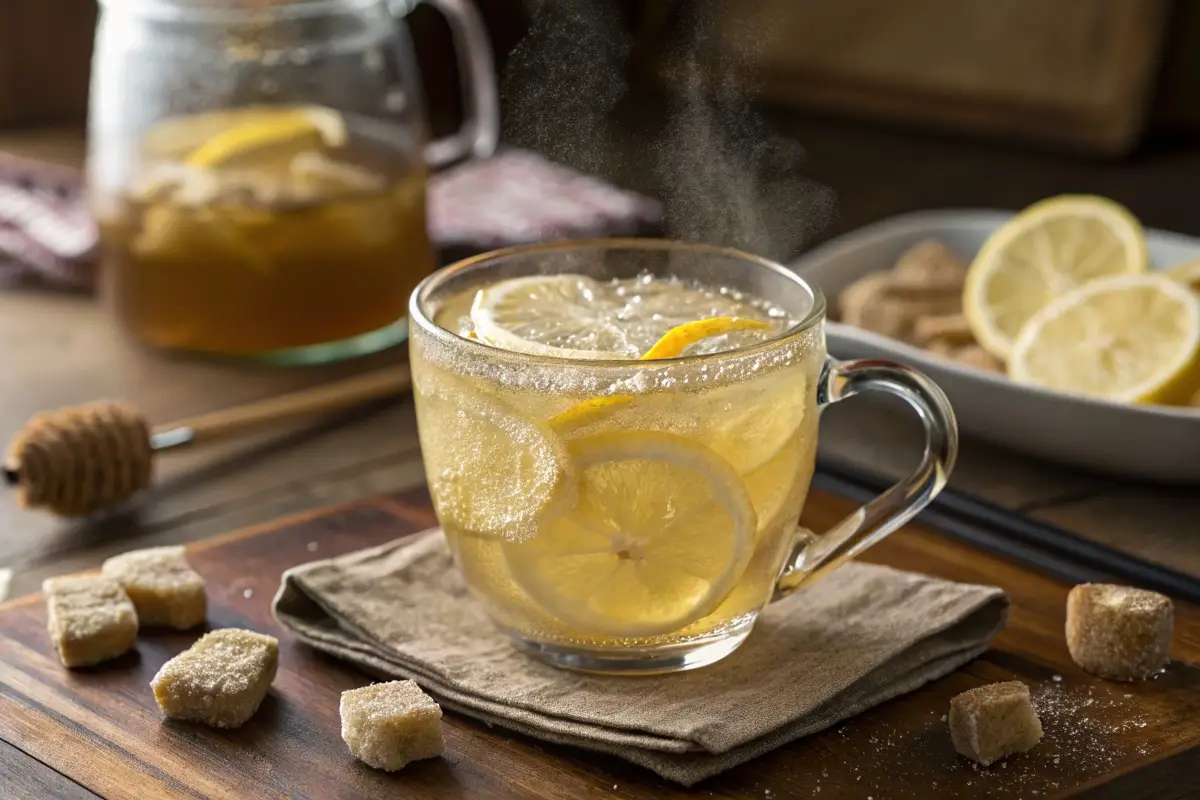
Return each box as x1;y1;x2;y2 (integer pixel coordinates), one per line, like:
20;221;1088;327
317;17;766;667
42;576;138;667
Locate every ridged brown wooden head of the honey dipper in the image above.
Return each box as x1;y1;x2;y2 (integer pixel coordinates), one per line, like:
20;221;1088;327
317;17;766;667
5;402;154;517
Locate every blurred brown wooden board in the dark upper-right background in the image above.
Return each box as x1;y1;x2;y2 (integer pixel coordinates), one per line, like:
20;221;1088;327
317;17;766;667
643;0;1170;155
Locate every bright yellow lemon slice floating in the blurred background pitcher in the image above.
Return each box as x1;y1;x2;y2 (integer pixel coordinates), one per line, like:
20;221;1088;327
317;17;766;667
185;106;346;167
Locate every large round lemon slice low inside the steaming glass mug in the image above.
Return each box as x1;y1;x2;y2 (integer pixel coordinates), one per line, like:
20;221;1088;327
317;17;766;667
505;432;757;638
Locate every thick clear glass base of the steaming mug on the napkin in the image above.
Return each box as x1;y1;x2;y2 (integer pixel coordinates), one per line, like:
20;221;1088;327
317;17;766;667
508;614;757;675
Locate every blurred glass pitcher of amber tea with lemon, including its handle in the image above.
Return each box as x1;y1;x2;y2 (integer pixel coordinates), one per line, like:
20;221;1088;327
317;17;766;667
88;0;499;363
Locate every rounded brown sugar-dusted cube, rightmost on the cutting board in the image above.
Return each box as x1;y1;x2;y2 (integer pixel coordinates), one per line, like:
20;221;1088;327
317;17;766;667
1067;583;1175;680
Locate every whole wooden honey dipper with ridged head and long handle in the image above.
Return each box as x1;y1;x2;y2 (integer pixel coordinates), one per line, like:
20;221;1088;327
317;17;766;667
4;365;410;517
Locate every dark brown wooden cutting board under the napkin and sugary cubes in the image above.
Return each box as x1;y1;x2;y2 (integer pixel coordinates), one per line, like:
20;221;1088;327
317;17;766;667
0;484;1200;800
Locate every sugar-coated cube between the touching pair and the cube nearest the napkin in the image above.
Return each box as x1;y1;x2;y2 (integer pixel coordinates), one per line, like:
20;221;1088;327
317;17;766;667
150;627;280;728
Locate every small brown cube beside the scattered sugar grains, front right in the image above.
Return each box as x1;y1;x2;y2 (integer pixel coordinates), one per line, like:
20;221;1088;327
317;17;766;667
949;680;1042;766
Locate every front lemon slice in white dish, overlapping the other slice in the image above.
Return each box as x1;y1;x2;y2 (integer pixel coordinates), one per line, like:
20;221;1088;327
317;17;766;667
1009;275;1200;403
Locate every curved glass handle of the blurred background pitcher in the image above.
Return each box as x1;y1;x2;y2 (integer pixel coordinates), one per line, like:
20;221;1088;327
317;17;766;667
425;0;500;168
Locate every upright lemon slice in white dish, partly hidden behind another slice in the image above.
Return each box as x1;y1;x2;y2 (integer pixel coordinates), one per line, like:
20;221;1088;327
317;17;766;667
962;194;1148;361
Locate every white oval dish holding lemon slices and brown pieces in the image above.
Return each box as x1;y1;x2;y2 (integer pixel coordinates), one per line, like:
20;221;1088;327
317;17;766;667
792;210;1200;483
